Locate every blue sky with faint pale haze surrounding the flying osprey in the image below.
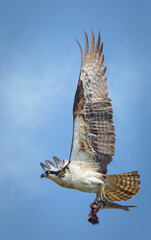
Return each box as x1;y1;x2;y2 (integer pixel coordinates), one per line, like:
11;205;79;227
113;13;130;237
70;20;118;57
0;0;151;240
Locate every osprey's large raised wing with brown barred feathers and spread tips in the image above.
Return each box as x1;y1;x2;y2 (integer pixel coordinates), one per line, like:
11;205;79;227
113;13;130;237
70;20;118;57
70;31;116;173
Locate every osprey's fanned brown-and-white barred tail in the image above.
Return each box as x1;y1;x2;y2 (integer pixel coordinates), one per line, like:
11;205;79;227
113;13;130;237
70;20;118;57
105;171;141;201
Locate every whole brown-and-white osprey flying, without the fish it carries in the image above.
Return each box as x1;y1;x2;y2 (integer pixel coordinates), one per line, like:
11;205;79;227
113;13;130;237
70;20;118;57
41;31;140;223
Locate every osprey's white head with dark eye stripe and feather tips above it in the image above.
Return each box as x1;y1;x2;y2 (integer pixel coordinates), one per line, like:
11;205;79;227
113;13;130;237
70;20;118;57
40;157;69;181
